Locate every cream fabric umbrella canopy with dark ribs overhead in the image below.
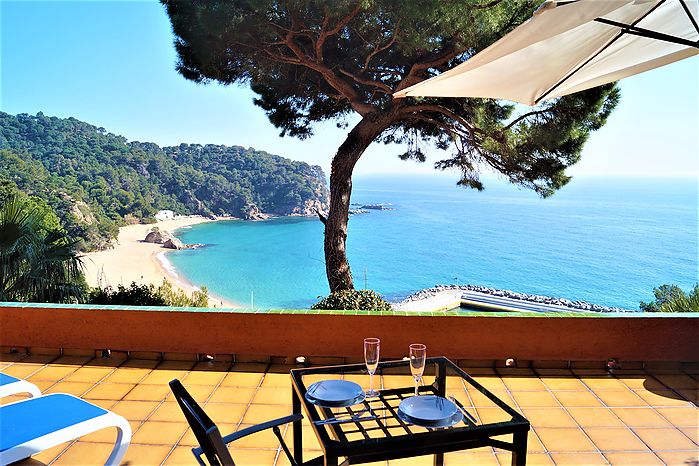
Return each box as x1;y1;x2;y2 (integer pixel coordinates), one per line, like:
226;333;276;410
394;0;699;105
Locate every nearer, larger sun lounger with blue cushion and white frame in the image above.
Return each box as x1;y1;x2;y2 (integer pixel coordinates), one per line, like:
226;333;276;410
0;393;131;466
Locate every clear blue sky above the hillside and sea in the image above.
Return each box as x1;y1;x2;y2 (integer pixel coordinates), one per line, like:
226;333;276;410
0;0;699;177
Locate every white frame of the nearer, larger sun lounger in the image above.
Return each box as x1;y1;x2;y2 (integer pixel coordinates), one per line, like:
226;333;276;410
0;395;131;466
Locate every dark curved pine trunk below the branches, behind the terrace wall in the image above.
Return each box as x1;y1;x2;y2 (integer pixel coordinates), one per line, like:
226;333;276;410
324;115;388;293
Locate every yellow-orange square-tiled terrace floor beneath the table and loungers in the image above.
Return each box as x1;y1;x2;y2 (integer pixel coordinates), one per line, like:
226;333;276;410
0;354;699;466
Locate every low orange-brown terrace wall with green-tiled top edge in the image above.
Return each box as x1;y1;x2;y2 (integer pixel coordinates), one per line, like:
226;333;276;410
0;303;699;361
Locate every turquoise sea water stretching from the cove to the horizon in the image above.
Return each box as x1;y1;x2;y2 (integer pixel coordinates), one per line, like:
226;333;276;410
168;176;699;309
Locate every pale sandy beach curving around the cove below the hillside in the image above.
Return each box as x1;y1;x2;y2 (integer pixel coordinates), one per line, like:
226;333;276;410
83;216;241;307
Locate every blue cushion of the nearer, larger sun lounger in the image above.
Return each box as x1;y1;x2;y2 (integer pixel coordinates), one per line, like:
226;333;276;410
0;393;108;451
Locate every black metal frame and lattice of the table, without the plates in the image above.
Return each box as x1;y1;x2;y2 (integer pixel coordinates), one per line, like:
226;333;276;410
291;357;530;466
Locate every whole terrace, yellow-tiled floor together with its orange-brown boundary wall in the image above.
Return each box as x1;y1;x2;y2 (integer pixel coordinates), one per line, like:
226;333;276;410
0;303;699;465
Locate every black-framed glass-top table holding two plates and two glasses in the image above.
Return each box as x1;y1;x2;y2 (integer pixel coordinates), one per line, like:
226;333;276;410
291;357;530;466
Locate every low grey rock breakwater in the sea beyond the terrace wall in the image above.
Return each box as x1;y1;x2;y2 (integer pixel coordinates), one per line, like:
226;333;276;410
397;285;634;312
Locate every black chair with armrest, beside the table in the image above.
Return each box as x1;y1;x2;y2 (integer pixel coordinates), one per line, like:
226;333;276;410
170;379;323;466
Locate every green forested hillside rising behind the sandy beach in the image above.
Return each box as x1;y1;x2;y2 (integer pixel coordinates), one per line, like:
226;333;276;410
0;112;328;249
